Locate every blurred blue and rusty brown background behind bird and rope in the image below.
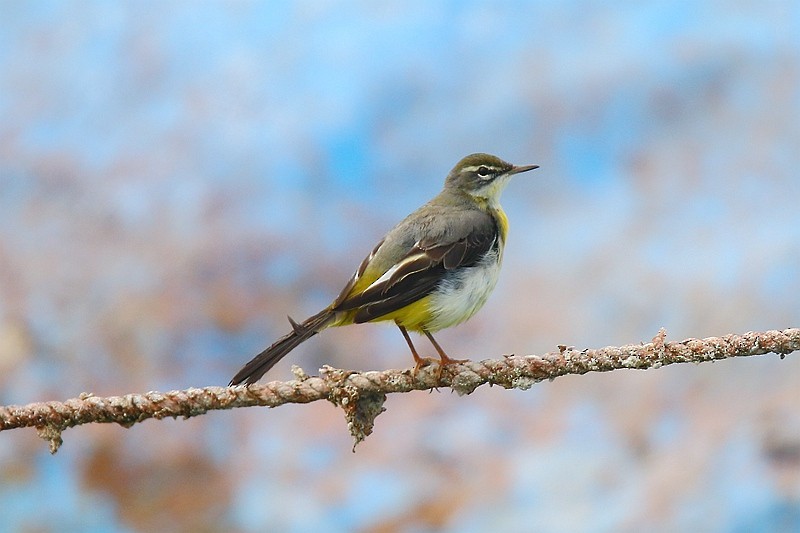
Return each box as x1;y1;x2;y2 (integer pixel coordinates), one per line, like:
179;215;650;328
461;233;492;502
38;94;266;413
0;0;800;532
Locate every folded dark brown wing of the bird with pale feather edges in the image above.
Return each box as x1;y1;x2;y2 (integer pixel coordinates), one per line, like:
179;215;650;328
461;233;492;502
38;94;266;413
335;212;498;323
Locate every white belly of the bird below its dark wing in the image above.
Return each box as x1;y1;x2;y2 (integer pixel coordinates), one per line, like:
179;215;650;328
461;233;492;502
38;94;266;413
426;248;500;331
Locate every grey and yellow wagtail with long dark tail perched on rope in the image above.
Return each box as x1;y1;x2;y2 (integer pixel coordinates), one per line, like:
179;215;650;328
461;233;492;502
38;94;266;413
230;154;539;385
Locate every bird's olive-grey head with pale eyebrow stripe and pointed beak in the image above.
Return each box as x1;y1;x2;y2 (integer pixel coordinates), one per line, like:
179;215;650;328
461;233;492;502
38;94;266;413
445;154;539;204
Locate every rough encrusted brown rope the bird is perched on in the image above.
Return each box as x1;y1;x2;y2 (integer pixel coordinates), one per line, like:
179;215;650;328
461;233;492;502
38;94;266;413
0;328;800;453
